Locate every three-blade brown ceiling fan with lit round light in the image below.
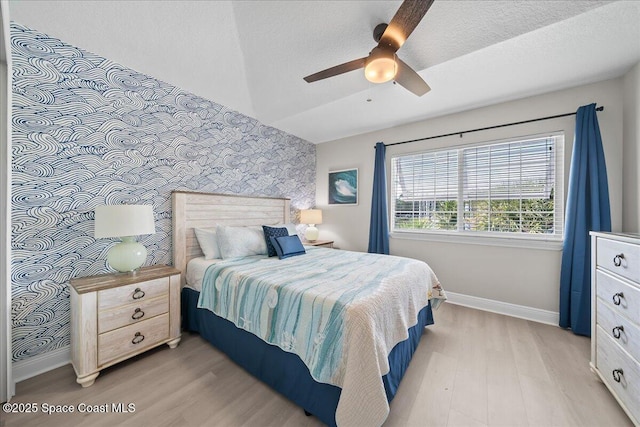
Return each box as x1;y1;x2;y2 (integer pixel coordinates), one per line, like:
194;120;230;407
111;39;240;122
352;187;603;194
304;0;434;96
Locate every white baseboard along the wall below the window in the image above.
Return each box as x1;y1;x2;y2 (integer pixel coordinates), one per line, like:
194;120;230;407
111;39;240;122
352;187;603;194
446;291;560;326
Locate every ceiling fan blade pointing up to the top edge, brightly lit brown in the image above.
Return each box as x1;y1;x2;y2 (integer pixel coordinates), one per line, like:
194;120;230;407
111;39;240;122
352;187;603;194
378;0;433;52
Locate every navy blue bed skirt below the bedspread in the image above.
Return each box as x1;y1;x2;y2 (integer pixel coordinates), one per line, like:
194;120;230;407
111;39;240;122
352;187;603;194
182;288;433;426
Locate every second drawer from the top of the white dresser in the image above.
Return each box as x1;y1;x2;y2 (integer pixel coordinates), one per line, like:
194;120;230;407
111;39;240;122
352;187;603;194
596;271;640;322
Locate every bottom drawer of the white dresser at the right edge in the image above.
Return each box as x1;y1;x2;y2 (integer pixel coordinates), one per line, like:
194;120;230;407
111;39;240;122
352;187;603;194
596;326;640;420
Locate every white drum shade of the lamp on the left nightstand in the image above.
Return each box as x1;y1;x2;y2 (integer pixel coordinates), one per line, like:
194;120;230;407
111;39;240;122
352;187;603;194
94;205;156;239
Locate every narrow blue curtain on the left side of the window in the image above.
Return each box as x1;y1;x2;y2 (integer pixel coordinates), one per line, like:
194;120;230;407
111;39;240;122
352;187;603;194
369;142;389;255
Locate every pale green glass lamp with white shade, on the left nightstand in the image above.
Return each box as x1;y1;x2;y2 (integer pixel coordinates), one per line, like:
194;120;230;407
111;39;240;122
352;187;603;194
94;205;156;272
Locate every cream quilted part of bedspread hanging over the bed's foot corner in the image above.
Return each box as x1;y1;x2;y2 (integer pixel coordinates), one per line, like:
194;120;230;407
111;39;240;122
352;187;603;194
336;256;446;426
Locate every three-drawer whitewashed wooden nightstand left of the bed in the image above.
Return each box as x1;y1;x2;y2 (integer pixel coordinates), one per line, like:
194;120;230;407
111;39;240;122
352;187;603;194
70;265;180;387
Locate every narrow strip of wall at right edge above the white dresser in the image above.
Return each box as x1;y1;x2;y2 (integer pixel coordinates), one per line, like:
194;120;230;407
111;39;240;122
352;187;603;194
622;63;640;233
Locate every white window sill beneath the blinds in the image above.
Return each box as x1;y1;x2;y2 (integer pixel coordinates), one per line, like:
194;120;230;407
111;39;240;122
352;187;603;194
389;231;562;251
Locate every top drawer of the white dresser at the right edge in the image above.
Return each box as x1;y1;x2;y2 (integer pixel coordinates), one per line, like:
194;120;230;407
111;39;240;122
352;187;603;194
596;238;640;283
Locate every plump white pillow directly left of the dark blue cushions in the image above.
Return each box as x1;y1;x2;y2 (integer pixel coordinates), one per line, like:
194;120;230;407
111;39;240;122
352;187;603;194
216;225;267;259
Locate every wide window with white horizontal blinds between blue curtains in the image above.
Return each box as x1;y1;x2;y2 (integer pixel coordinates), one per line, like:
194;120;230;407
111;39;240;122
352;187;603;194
391;134;564;239
